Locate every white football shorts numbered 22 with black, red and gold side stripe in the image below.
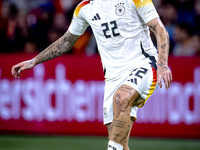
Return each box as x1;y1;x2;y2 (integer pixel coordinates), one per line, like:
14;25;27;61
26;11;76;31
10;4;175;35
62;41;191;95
103;58;158;124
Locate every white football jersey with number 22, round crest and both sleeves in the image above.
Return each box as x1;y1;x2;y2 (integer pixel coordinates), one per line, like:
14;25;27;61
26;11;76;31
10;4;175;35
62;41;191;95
69;0;159;79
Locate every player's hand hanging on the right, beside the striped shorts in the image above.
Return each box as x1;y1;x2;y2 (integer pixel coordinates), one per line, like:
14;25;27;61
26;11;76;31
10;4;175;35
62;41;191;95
157;66;172;90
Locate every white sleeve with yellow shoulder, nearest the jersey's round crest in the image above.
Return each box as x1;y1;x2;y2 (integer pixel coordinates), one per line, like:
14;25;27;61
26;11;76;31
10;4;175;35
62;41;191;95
133;0;159;23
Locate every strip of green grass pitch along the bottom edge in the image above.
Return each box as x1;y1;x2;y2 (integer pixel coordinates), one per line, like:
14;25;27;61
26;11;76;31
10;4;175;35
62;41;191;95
0;135;200;150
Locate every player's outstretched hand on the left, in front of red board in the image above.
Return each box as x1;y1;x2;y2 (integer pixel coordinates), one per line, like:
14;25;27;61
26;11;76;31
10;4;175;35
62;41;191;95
11;59;36;78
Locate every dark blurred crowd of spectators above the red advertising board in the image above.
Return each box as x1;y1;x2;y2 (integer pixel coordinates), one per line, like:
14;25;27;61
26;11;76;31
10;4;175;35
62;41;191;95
0;0;200;57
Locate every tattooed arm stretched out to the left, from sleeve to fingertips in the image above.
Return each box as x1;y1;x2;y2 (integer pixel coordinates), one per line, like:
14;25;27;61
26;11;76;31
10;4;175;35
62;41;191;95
11;31;80;78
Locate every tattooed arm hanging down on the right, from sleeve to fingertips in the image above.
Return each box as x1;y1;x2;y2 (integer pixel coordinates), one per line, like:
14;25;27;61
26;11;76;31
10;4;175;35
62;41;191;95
147;18;172;89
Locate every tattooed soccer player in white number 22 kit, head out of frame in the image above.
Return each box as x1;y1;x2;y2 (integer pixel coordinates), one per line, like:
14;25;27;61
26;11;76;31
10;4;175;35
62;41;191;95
12;0;172;150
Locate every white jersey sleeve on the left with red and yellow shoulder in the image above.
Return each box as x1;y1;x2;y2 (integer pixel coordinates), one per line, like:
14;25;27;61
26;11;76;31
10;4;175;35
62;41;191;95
68;1;89;35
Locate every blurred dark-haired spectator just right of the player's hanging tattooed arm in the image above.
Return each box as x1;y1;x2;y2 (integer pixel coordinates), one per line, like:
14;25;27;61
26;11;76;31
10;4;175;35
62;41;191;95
173;23;196;57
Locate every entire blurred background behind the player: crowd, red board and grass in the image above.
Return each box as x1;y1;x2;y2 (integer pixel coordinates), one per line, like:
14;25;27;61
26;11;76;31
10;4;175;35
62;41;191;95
0;0;200;150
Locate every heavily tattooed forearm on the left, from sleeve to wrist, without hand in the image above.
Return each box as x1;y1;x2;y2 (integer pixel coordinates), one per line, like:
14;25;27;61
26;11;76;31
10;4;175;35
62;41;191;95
35;31;79;64
